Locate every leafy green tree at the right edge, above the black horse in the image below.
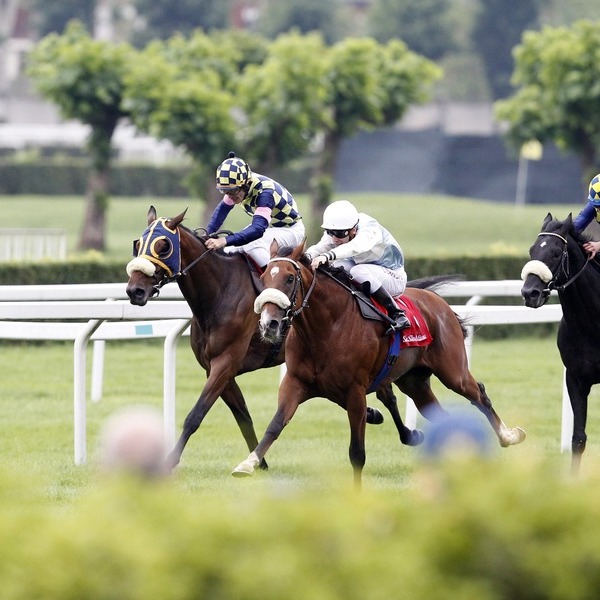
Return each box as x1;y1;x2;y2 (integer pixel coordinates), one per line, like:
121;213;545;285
495;21;600;177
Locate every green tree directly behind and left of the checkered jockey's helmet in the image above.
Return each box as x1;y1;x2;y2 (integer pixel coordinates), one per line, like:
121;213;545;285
125;30;263;222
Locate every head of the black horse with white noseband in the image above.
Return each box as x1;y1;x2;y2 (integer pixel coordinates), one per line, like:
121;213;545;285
521;213;585;308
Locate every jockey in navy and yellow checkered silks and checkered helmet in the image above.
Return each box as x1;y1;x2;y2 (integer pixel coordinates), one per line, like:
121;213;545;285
206;152;305;268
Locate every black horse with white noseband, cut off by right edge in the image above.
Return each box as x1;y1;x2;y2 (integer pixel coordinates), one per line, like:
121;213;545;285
521;213;600;474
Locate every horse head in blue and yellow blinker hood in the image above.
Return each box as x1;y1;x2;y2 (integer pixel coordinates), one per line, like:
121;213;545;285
127;206;187;306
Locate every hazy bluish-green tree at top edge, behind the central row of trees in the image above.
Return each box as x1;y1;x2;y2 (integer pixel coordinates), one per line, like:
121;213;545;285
368;0;456;60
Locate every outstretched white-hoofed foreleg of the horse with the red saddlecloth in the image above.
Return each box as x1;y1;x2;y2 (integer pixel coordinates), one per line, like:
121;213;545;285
231;373;304;477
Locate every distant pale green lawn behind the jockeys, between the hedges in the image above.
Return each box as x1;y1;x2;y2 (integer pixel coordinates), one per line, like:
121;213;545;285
0;193;581;260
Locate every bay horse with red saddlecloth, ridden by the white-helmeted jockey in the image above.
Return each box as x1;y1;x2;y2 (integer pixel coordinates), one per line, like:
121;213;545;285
233;246;525;487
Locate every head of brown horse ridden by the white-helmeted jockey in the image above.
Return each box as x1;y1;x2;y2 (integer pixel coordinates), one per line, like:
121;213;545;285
254;240;308;344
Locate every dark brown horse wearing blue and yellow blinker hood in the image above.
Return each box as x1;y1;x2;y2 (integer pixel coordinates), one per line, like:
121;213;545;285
127;206;396;468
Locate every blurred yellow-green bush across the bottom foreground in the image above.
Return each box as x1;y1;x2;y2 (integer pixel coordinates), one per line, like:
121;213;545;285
0;460;600;600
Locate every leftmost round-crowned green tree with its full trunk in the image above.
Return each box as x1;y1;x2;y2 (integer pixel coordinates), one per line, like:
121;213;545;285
28;21;134;251
